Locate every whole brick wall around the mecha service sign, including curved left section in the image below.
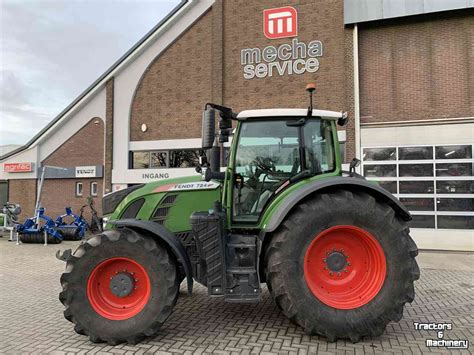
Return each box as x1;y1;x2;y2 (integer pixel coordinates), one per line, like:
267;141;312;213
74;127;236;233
130;0;353;161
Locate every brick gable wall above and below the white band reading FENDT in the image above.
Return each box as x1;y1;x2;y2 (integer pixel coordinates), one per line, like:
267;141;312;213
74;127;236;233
41;118;104;218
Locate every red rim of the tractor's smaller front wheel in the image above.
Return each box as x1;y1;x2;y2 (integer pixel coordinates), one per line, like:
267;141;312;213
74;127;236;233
87;257;151;320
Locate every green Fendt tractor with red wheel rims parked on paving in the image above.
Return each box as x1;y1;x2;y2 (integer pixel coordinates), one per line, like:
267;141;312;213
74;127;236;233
59;85;420;345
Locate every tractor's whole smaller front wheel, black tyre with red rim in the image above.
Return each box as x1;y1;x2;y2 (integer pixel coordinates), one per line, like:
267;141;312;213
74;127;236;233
59;228;179;345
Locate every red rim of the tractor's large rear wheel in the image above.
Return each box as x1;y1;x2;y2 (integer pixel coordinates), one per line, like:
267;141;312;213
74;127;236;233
304;226;387;309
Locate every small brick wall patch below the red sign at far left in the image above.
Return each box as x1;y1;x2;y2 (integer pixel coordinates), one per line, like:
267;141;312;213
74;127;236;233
8;179;37;223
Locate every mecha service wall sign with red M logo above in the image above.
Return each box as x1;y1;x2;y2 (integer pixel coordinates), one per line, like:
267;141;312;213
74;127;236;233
240;6;323;79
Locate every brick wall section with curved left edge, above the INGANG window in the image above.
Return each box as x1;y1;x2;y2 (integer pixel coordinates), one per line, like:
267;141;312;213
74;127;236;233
130;10;212;141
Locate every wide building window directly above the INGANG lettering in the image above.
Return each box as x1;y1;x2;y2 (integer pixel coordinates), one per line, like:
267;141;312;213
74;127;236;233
131;149;204;169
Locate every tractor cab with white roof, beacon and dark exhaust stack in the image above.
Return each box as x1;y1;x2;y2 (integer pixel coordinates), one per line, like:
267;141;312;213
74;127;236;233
202;85;347;227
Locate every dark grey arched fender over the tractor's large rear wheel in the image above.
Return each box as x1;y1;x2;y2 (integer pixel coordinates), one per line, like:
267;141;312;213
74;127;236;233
263;176;412;233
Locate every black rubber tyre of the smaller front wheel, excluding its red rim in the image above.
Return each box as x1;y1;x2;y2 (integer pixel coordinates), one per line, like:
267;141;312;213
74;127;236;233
59;228;179;345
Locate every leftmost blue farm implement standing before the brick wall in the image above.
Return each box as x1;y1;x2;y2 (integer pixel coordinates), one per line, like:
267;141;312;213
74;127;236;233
16;207;63;244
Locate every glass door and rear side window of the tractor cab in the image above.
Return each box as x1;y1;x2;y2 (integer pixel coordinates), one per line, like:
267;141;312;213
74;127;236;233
233;118;335;222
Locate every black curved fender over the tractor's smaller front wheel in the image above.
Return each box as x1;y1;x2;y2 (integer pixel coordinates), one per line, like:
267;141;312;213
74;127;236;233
108;218;193;293
